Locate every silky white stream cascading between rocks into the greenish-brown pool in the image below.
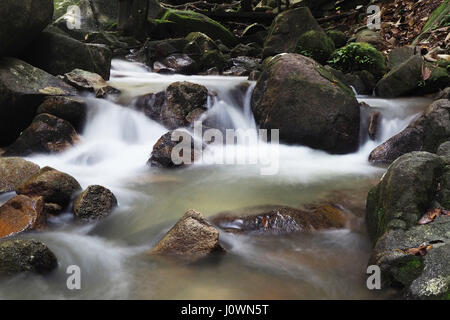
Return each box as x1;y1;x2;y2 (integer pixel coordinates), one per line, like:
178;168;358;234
0;60;430;299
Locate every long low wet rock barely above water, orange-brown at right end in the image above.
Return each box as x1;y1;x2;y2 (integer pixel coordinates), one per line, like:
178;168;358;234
212;204;348;234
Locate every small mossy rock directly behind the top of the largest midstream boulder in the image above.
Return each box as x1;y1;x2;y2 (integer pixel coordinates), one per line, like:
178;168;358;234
295;30;335;64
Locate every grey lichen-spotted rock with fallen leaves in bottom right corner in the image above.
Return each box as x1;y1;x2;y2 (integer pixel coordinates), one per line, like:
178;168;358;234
369;216;450;299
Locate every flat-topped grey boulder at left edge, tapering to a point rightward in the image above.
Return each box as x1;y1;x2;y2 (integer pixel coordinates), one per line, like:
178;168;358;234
0;58;76;147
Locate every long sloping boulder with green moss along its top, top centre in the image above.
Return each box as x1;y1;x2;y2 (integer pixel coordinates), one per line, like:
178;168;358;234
158;9;237;46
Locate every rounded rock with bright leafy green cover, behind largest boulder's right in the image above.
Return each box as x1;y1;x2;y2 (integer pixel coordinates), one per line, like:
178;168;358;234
329;42;386;78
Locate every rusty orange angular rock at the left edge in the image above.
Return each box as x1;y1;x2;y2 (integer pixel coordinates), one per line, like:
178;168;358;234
0;195;45;239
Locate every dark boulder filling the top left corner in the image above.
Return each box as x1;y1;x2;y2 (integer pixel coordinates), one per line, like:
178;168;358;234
0;0;53;56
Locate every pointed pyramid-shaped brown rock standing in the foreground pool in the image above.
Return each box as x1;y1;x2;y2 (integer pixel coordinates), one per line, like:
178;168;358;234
151;210;224;262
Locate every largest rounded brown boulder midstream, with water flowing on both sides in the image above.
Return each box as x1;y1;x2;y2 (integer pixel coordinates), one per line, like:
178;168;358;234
251;54;360;153
